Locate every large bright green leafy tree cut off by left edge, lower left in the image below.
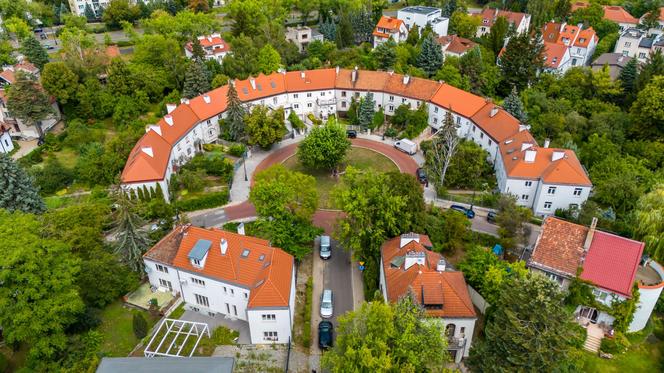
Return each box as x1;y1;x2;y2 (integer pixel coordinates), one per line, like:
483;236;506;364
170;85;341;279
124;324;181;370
0;210;83;364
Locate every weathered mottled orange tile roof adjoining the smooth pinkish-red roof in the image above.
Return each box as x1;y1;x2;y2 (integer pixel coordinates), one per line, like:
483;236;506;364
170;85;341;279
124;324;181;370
528;217;588;277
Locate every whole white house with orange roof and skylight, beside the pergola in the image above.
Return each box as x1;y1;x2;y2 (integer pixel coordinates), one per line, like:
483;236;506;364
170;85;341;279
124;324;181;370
143;225;295;344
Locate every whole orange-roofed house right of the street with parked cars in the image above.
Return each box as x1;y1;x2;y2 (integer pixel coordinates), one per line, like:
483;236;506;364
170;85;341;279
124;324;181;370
380;233;477;363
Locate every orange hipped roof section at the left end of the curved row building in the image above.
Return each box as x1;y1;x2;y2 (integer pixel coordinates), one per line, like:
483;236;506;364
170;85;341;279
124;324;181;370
120;130;171;183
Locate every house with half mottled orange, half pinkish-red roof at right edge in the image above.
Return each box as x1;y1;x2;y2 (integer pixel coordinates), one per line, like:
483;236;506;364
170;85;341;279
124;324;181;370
528;217;664;333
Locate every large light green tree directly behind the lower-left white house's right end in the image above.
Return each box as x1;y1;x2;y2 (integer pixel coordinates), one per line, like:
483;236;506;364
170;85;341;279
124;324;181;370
249;165;319;260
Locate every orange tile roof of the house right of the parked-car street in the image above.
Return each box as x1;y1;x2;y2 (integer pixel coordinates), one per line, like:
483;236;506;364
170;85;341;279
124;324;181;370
381;235;477;318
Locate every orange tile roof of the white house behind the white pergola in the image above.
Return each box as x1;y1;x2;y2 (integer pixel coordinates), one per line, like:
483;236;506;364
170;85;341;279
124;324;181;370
158;226;294;308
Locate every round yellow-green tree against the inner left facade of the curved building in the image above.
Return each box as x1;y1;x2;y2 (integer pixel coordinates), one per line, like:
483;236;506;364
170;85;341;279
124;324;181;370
244;105;287;149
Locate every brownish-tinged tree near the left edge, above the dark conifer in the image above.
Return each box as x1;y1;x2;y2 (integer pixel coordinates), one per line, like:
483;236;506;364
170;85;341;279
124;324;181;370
7;71;53;140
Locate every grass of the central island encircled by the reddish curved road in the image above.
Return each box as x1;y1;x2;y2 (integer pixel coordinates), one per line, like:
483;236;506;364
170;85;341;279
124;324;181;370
284;147;399;209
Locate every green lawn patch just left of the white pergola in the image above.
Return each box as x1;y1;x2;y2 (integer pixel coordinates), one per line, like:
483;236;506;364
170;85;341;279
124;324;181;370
99;300;158;357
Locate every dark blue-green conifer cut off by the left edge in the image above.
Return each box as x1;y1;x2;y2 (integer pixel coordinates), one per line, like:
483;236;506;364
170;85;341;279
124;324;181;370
0;153;46;214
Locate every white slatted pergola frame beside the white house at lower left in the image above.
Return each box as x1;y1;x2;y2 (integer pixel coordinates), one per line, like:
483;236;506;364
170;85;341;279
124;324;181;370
143;319;210;357
